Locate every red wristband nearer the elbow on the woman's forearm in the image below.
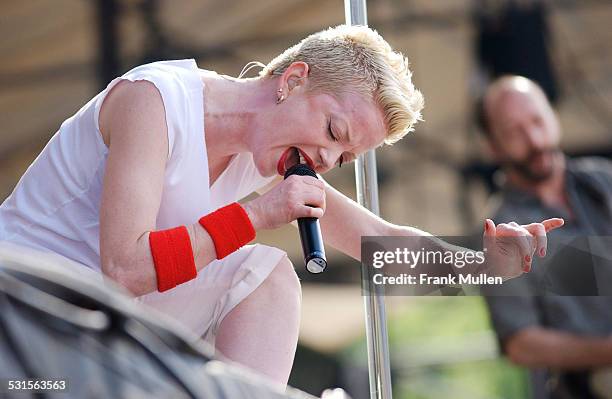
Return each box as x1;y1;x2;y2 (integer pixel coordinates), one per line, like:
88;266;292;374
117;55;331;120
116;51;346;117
149;226;198;292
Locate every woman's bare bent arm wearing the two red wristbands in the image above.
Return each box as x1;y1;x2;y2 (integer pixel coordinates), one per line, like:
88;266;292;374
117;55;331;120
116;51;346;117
100;81;216;295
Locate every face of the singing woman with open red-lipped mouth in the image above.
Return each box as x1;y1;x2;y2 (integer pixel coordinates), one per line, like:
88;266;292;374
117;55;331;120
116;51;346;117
252;90;386;176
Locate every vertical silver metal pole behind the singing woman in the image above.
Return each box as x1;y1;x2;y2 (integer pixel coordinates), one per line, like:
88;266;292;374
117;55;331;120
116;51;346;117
344;0;392;399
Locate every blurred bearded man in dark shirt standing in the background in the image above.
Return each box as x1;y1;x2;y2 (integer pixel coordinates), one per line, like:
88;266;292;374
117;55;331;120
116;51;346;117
482;76;612;399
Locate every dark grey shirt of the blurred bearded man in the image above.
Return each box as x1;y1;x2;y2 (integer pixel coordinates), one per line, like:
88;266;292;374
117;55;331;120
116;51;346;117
487;158;612;399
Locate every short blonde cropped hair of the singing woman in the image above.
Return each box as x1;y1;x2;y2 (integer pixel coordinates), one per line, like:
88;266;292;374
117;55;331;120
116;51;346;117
261;25;424;144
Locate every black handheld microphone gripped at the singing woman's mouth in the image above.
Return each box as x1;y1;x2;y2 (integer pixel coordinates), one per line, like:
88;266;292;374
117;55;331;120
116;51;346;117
285;163;327;273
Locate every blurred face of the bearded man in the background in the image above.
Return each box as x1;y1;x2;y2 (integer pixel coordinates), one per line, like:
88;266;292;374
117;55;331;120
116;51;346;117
487;90;560;182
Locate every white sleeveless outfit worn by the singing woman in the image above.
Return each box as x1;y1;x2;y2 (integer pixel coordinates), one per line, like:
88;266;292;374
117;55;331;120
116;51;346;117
0;60;284;344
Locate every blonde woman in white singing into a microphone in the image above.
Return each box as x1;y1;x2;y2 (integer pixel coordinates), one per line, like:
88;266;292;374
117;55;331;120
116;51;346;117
0;26;562;384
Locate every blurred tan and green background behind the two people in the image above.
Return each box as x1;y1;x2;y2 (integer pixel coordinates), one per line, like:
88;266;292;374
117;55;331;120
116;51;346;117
0;0;612;399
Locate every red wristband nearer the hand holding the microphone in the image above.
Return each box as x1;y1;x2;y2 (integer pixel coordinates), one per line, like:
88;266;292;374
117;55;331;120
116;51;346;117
200;202;255;259
